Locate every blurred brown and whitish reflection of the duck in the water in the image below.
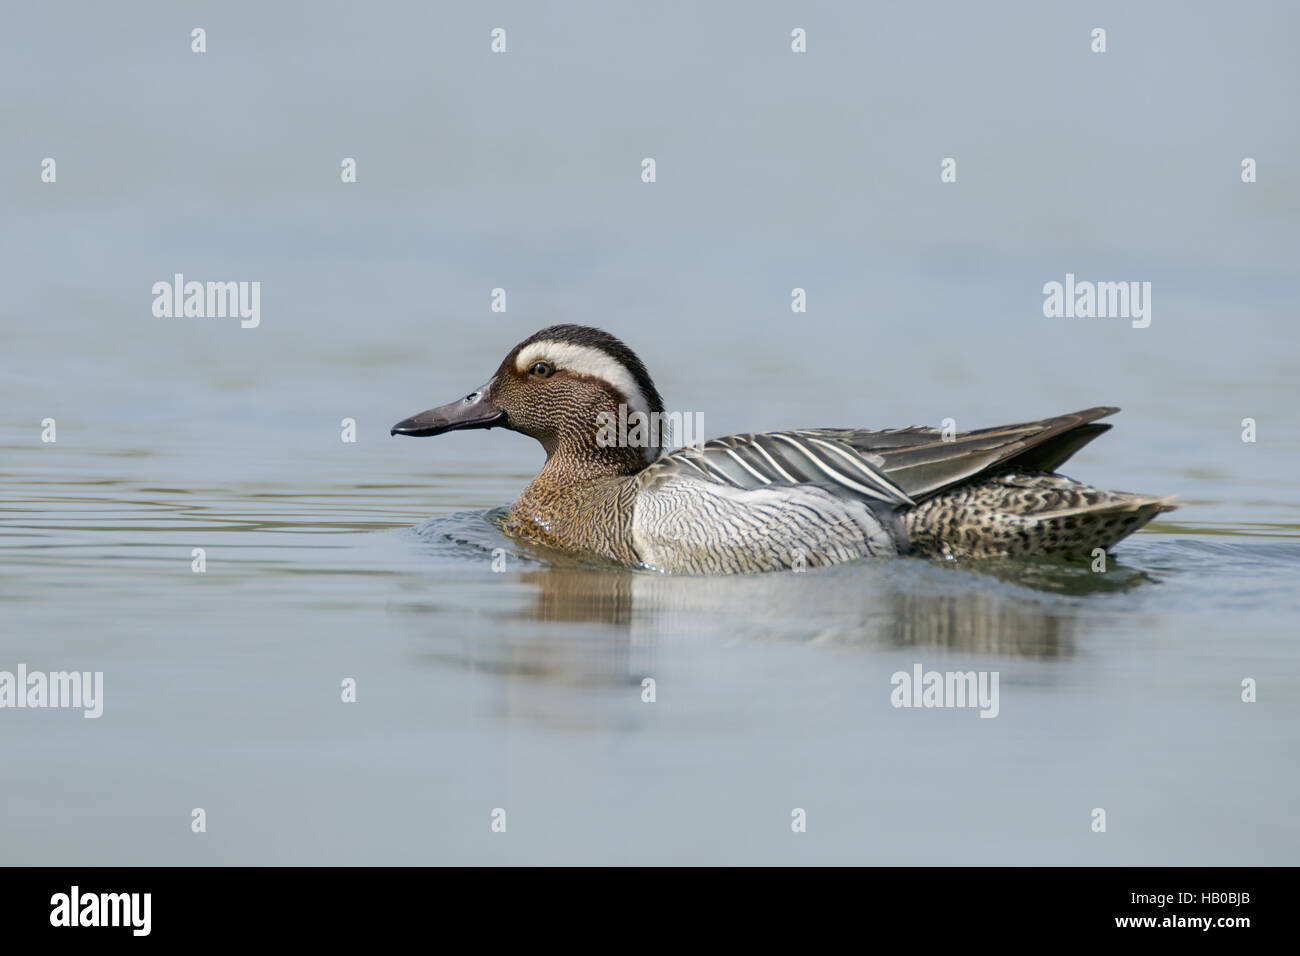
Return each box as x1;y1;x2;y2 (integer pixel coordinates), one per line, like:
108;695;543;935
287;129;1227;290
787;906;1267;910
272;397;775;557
390;530;1151;700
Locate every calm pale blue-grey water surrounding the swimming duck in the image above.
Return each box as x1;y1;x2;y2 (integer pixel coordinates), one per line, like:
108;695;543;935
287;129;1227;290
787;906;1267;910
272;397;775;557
0;4;1300;864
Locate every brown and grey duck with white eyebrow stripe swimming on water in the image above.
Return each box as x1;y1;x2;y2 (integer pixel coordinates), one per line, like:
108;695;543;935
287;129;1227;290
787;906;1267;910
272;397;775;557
390;324;1177;575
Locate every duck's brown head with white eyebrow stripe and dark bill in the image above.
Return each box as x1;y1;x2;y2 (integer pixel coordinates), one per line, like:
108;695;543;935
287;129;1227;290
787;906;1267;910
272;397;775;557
391;325;667;475
